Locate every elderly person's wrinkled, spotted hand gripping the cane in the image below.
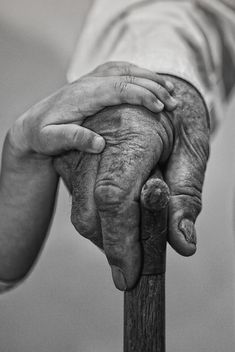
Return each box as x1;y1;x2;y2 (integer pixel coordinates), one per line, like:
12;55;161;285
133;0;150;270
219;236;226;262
55;77;209;290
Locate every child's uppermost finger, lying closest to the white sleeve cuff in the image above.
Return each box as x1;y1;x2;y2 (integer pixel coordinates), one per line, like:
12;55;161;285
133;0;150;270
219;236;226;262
92;61;174;93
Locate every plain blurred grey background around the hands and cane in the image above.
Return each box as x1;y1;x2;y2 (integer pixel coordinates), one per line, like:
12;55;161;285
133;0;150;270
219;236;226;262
0;0;235;352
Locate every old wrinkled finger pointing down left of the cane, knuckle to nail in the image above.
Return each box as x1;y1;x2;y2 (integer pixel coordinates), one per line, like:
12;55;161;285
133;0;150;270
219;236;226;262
95;185;141;291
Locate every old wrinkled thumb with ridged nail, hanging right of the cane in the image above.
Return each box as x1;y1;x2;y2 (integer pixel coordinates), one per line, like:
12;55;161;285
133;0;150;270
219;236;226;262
163;128;209;256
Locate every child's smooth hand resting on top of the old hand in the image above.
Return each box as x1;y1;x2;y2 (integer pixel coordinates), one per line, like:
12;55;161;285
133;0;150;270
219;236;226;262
10;62;177;156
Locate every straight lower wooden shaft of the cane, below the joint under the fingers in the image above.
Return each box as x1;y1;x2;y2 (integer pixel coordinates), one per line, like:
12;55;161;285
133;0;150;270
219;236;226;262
124;274;165;352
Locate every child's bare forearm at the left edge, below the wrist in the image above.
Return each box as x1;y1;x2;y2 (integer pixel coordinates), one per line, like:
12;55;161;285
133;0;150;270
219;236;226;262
0;134;58;281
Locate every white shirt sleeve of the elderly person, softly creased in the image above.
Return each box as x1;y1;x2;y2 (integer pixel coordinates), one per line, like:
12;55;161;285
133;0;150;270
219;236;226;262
68;0;235;129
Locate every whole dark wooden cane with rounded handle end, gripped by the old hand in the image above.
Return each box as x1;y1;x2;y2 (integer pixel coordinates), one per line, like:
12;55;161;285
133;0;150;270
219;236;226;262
124;170;170;352
